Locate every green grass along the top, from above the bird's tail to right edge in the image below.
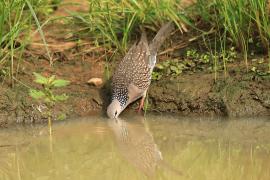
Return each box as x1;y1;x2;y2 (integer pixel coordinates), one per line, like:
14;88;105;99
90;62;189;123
72;0;270;75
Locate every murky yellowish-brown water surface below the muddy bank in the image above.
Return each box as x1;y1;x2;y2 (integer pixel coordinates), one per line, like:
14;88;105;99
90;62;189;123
0;114;270;180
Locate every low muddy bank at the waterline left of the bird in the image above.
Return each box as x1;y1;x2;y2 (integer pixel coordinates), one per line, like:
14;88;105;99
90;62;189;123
0;83;102;127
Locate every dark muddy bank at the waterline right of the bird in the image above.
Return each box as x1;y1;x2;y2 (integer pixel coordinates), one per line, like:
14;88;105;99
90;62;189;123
149;73;270;116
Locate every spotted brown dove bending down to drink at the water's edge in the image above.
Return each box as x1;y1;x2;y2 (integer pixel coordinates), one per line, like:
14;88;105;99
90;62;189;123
107;22;174;118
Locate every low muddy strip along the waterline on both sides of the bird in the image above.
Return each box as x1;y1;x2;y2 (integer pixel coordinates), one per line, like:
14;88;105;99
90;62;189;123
0;67;270;127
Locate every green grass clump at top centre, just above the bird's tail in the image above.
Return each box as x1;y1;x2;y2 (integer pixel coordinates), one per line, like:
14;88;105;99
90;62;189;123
74;0;191;53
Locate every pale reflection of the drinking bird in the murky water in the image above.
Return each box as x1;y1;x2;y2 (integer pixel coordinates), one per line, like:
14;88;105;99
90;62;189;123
108;116;182;177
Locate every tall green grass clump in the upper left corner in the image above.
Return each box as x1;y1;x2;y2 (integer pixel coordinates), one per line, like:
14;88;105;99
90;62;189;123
0;0;52;85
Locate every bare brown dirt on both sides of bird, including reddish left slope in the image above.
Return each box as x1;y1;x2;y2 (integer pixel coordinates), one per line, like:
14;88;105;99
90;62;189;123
0;0;270;127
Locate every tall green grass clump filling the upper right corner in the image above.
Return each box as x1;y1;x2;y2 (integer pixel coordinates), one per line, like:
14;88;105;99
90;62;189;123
197;0;270;71
